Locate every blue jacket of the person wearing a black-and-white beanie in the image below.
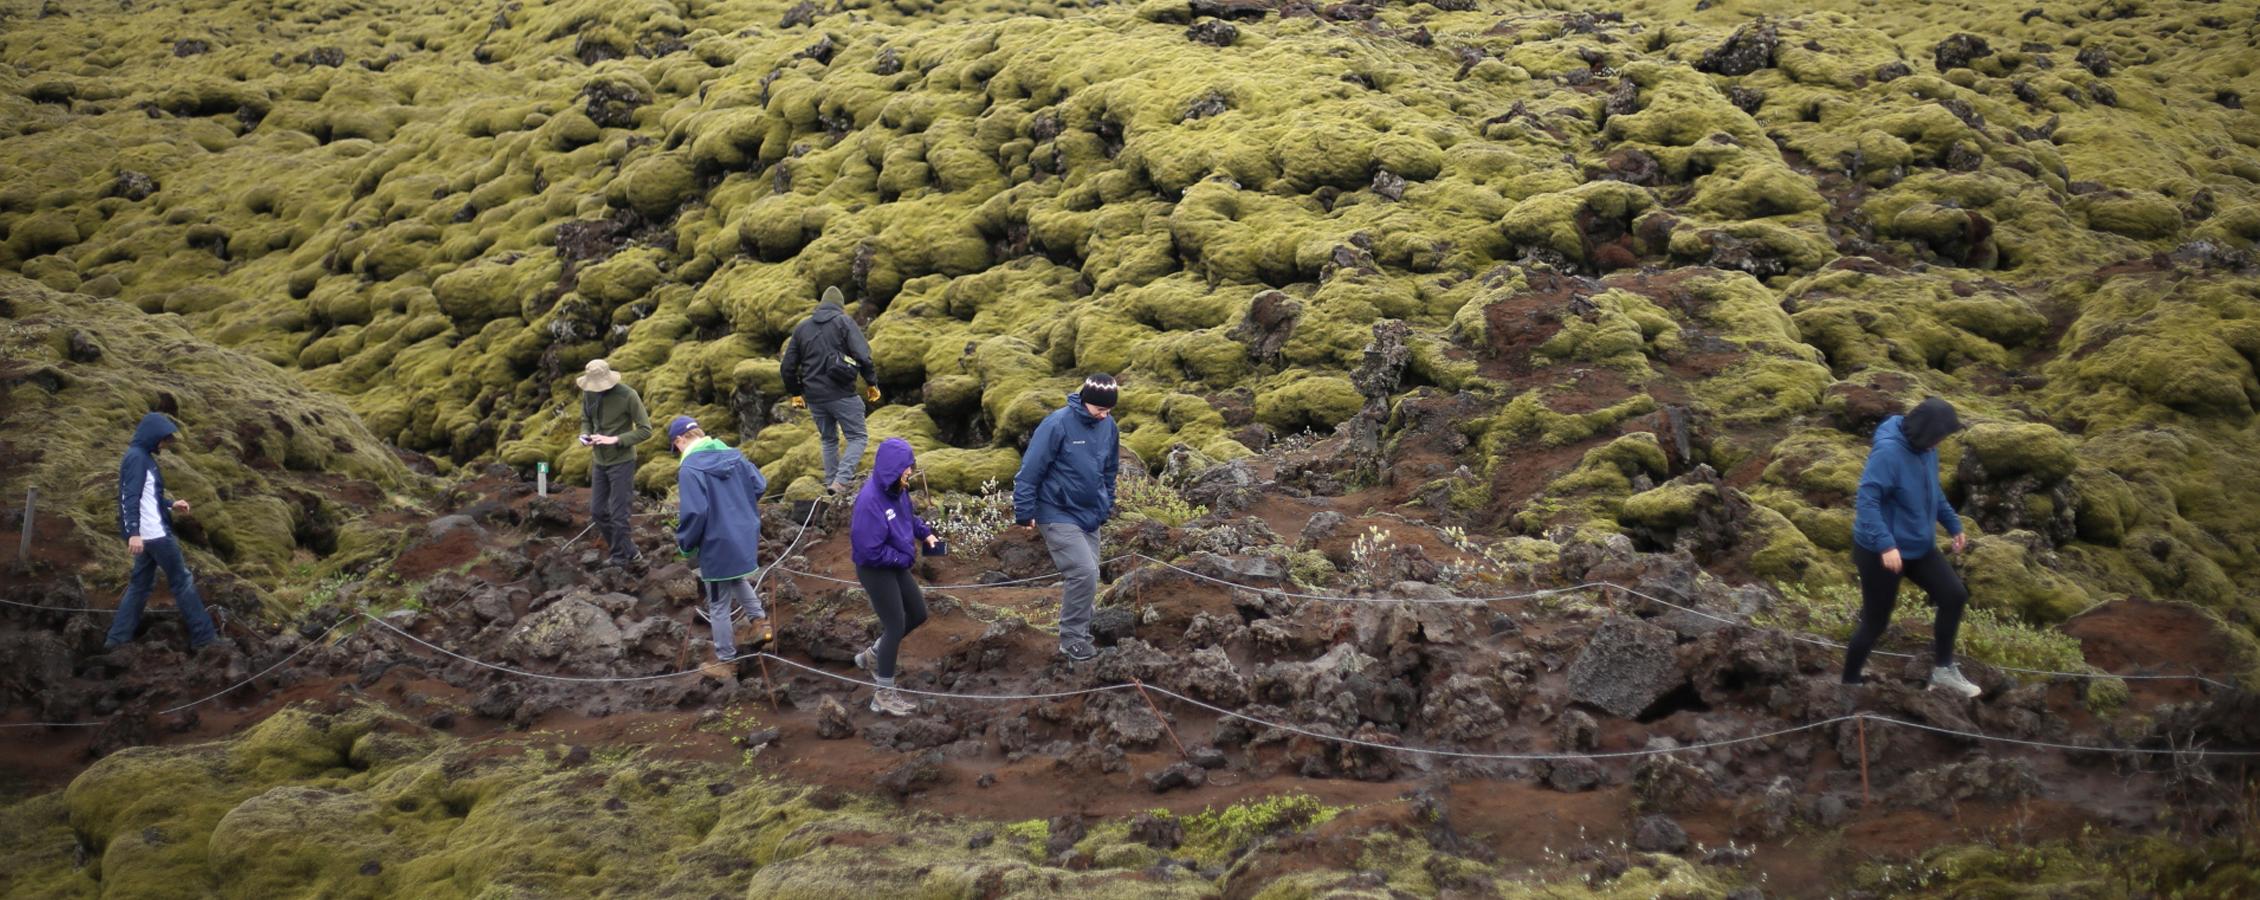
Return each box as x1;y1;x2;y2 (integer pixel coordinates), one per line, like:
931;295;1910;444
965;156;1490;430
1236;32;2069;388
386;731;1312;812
1012;391;1121;531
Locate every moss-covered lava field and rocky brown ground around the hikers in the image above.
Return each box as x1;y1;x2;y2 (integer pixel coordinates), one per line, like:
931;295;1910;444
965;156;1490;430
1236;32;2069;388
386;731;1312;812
0;0;2260;895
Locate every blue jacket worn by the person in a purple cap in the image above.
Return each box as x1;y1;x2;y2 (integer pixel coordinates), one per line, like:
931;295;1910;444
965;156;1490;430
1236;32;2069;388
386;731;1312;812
676;439;768;581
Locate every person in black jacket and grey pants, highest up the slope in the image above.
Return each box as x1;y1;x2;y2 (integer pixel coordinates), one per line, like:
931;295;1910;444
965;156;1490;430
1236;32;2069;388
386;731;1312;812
780;287;879;493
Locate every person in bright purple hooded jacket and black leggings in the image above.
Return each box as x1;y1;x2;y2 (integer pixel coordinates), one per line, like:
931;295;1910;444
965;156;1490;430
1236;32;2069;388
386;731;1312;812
848;436;942;715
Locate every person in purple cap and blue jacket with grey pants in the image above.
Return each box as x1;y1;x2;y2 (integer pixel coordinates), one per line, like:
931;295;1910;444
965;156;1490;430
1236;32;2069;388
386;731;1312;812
667;416;775;676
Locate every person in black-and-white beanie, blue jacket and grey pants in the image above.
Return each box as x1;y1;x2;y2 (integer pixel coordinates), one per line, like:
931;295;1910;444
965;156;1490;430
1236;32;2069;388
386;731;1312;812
1012;373;1121;663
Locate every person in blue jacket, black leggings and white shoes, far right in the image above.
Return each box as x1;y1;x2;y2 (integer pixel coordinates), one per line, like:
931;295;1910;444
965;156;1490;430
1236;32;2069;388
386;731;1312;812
1844;398;1980;696
